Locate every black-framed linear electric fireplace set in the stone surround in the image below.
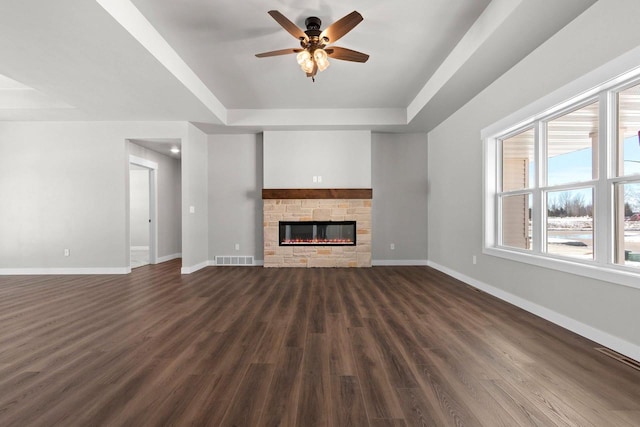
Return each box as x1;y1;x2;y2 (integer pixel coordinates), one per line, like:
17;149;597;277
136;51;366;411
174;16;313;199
279;221;356;246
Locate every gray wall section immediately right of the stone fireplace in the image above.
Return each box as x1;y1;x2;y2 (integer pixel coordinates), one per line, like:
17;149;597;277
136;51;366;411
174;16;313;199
371;133;427;264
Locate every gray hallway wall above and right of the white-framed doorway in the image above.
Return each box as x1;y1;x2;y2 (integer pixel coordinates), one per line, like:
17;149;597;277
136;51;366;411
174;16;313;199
129;143;182;262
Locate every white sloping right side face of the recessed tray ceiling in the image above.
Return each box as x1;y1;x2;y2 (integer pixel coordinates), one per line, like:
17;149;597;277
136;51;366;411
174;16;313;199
407;0;522;122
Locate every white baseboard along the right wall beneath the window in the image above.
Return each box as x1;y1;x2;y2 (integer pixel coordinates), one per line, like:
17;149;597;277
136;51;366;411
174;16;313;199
428;261;640;360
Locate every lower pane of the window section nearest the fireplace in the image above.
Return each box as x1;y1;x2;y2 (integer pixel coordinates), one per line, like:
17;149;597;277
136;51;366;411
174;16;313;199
501;194;532;249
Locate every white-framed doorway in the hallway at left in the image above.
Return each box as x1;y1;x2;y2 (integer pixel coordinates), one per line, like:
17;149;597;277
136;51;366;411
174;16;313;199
129;156;158;268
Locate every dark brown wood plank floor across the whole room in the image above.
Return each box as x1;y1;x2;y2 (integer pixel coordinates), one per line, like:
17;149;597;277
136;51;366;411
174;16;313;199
0;260;640;427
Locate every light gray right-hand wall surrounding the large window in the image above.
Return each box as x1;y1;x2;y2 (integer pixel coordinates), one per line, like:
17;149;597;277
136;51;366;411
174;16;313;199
428;0;640;354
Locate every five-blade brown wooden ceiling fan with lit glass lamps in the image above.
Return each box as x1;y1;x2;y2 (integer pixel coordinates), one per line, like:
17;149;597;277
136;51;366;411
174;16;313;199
256;10;369;82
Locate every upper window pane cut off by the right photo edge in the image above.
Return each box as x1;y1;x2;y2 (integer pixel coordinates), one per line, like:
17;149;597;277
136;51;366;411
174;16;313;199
618;85;640;176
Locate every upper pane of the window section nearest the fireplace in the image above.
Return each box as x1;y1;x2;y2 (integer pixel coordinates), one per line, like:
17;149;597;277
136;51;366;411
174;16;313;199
502;129;535;191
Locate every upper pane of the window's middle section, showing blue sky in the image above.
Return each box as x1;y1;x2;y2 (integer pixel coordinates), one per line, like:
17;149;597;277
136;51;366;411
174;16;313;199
547;102;598;186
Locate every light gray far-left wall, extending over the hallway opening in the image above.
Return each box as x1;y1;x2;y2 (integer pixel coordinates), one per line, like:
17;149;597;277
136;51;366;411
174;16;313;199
0;122;185;273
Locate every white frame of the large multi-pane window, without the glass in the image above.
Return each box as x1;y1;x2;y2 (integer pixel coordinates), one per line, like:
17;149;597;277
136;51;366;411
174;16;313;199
481;47;640;289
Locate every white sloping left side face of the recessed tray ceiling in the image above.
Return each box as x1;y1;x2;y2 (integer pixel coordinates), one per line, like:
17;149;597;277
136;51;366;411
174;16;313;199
96;0;227;124
